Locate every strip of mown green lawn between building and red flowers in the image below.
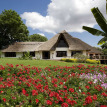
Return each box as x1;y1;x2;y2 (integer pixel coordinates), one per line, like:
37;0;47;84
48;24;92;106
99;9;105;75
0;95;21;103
0;58;99;68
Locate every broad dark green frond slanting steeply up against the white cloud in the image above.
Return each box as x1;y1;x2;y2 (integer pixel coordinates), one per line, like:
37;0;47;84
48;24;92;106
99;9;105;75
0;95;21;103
91;8;107;33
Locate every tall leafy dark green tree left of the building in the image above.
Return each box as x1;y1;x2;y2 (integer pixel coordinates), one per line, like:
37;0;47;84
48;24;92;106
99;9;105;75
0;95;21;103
0;10;29;49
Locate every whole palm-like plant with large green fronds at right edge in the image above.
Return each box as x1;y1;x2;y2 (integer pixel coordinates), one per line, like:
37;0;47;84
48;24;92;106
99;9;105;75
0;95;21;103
83;6;107;45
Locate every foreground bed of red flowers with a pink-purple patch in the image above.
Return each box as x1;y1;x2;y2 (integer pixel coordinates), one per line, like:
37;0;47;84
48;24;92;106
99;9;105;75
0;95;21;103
0;64;107;107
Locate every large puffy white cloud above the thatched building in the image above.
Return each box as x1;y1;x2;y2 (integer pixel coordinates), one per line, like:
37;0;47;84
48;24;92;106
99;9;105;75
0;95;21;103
21;0;106;33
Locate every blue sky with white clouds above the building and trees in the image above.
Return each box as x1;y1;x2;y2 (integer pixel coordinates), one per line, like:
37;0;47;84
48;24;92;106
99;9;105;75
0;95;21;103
0;0;107;47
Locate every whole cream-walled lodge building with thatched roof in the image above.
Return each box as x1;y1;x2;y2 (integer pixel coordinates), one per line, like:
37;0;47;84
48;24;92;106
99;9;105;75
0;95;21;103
2;30;101;59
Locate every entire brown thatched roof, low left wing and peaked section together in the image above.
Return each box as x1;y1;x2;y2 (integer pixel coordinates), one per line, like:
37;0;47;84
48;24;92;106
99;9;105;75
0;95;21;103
2;30;101;53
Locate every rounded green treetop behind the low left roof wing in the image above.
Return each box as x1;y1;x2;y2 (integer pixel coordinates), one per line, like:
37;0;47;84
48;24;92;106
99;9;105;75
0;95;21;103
28;34;48;42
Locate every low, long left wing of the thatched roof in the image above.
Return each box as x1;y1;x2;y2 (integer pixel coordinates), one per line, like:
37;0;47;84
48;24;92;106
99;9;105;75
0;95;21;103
2;42;44;52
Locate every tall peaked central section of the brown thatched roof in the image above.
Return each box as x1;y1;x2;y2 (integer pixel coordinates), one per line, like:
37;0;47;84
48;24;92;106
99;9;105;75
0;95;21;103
39;30;91;51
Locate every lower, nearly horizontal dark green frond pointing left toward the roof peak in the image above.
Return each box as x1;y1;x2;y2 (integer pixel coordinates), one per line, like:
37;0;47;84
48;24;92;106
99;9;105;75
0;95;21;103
83;26;105;36
